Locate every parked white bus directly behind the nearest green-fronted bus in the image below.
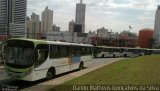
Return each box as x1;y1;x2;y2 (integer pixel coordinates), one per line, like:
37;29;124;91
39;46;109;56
96;46;121;58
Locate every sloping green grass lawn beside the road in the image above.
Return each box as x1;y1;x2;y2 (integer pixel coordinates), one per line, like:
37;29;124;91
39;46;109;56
49;55;160;91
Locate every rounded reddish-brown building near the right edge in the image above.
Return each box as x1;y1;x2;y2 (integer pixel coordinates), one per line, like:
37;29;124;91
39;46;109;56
138;28;153;48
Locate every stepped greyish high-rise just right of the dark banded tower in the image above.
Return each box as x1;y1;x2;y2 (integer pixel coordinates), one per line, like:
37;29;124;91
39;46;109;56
27;13;41;39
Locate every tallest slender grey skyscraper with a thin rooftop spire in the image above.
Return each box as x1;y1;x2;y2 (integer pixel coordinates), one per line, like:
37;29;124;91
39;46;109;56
75;0;86;33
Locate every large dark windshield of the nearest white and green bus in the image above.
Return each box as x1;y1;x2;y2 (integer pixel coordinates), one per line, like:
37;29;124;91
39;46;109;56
6;41;34;68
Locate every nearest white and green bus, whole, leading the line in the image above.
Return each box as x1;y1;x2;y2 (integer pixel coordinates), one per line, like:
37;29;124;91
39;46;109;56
5;39;93;81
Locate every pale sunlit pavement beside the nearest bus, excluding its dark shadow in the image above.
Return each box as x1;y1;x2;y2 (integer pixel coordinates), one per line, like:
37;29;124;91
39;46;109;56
22;58;123;91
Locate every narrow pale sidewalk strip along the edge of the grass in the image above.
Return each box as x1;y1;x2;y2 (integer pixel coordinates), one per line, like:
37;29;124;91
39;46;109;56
21;59;124;91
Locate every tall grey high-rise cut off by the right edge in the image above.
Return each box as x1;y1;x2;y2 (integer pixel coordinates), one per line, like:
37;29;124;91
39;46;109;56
154;6;160;47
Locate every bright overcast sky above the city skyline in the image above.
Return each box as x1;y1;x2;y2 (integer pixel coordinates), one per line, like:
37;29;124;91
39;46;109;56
27;0;160;33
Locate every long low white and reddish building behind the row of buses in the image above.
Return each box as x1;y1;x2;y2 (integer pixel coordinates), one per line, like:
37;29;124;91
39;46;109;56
45;28;138;47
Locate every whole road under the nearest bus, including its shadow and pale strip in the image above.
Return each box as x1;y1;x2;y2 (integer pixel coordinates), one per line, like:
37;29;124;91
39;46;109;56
0;58;124;91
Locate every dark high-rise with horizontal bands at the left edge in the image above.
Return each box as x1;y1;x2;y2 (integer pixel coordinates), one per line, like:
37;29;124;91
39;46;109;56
0;0;27;37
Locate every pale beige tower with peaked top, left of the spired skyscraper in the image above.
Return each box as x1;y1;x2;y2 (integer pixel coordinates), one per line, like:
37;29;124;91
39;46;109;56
41;7;53;33
